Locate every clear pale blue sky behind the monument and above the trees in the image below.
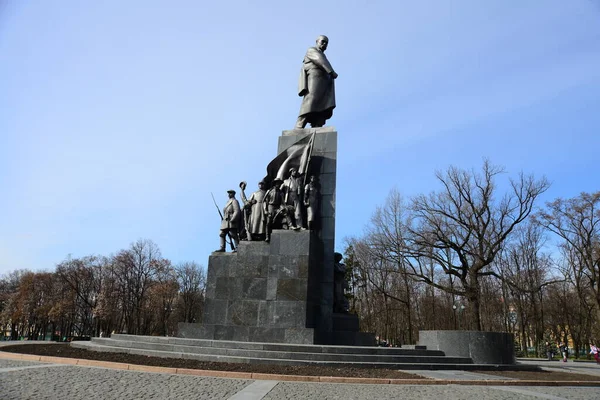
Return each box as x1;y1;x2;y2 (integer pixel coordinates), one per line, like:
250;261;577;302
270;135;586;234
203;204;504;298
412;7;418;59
0;0;600;275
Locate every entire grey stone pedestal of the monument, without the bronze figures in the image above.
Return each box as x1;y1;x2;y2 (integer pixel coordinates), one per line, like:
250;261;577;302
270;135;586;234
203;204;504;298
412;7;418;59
178;127;375;345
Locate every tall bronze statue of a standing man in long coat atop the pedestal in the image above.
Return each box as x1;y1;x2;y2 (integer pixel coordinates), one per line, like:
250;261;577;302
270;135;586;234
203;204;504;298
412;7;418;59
294;35;338;129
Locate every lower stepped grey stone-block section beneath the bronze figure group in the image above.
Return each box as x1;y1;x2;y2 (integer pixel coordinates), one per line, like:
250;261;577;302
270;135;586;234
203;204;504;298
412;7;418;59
179;230;320;344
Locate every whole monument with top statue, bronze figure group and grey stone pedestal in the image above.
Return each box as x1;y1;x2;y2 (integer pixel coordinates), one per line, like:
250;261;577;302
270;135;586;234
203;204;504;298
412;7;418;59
178;36;375;345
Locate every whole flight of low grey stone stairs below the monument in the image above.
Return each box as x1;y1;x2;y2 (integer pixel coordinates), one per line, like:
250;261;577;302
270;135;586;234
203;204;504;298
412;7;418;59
71;334;518;370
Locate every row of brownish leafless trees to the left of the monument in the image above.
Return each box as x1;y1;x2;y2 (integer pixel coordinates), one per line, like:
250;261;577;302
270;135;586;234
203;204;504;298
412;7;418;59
0;240;206;339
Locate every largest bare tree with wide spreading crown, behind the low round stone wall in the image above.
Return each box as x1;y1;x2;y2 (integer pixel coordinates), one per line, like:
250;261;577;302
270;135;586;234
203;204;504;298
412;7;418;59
407;160;549;330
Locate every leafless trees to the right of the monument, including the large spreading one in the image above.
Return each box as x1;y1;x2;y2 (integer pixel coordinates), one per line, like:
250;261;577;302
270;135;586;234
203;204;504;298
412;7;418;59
345;161;600;351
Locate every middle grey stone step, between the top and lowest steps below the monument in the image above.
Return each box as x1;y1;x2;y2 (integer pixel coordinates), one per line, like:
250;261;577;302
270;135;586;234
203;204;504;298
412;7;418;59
88;338;471;364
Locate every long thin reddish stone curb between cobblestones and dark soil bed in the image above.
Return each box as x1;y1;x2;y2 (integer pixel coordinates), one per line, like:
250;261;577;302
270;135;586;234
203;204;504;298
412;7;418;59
0;351;600;387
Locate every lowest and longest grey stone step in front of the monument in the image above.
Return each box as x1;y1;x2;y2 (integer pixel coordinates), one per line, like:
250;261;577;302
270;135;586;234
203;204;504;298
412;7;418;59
71;341;516;371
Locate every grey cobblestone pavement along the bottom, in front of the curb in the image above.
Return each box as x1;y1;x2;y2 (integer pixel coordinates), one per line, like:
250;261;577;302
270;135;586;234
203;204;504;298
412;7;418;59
0;359;600;400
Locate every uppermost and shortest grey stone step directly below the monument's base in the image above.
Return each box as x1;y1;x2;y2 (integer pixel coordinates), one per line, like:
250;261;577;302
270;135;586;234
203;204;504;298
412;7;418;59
110;334;445;356
